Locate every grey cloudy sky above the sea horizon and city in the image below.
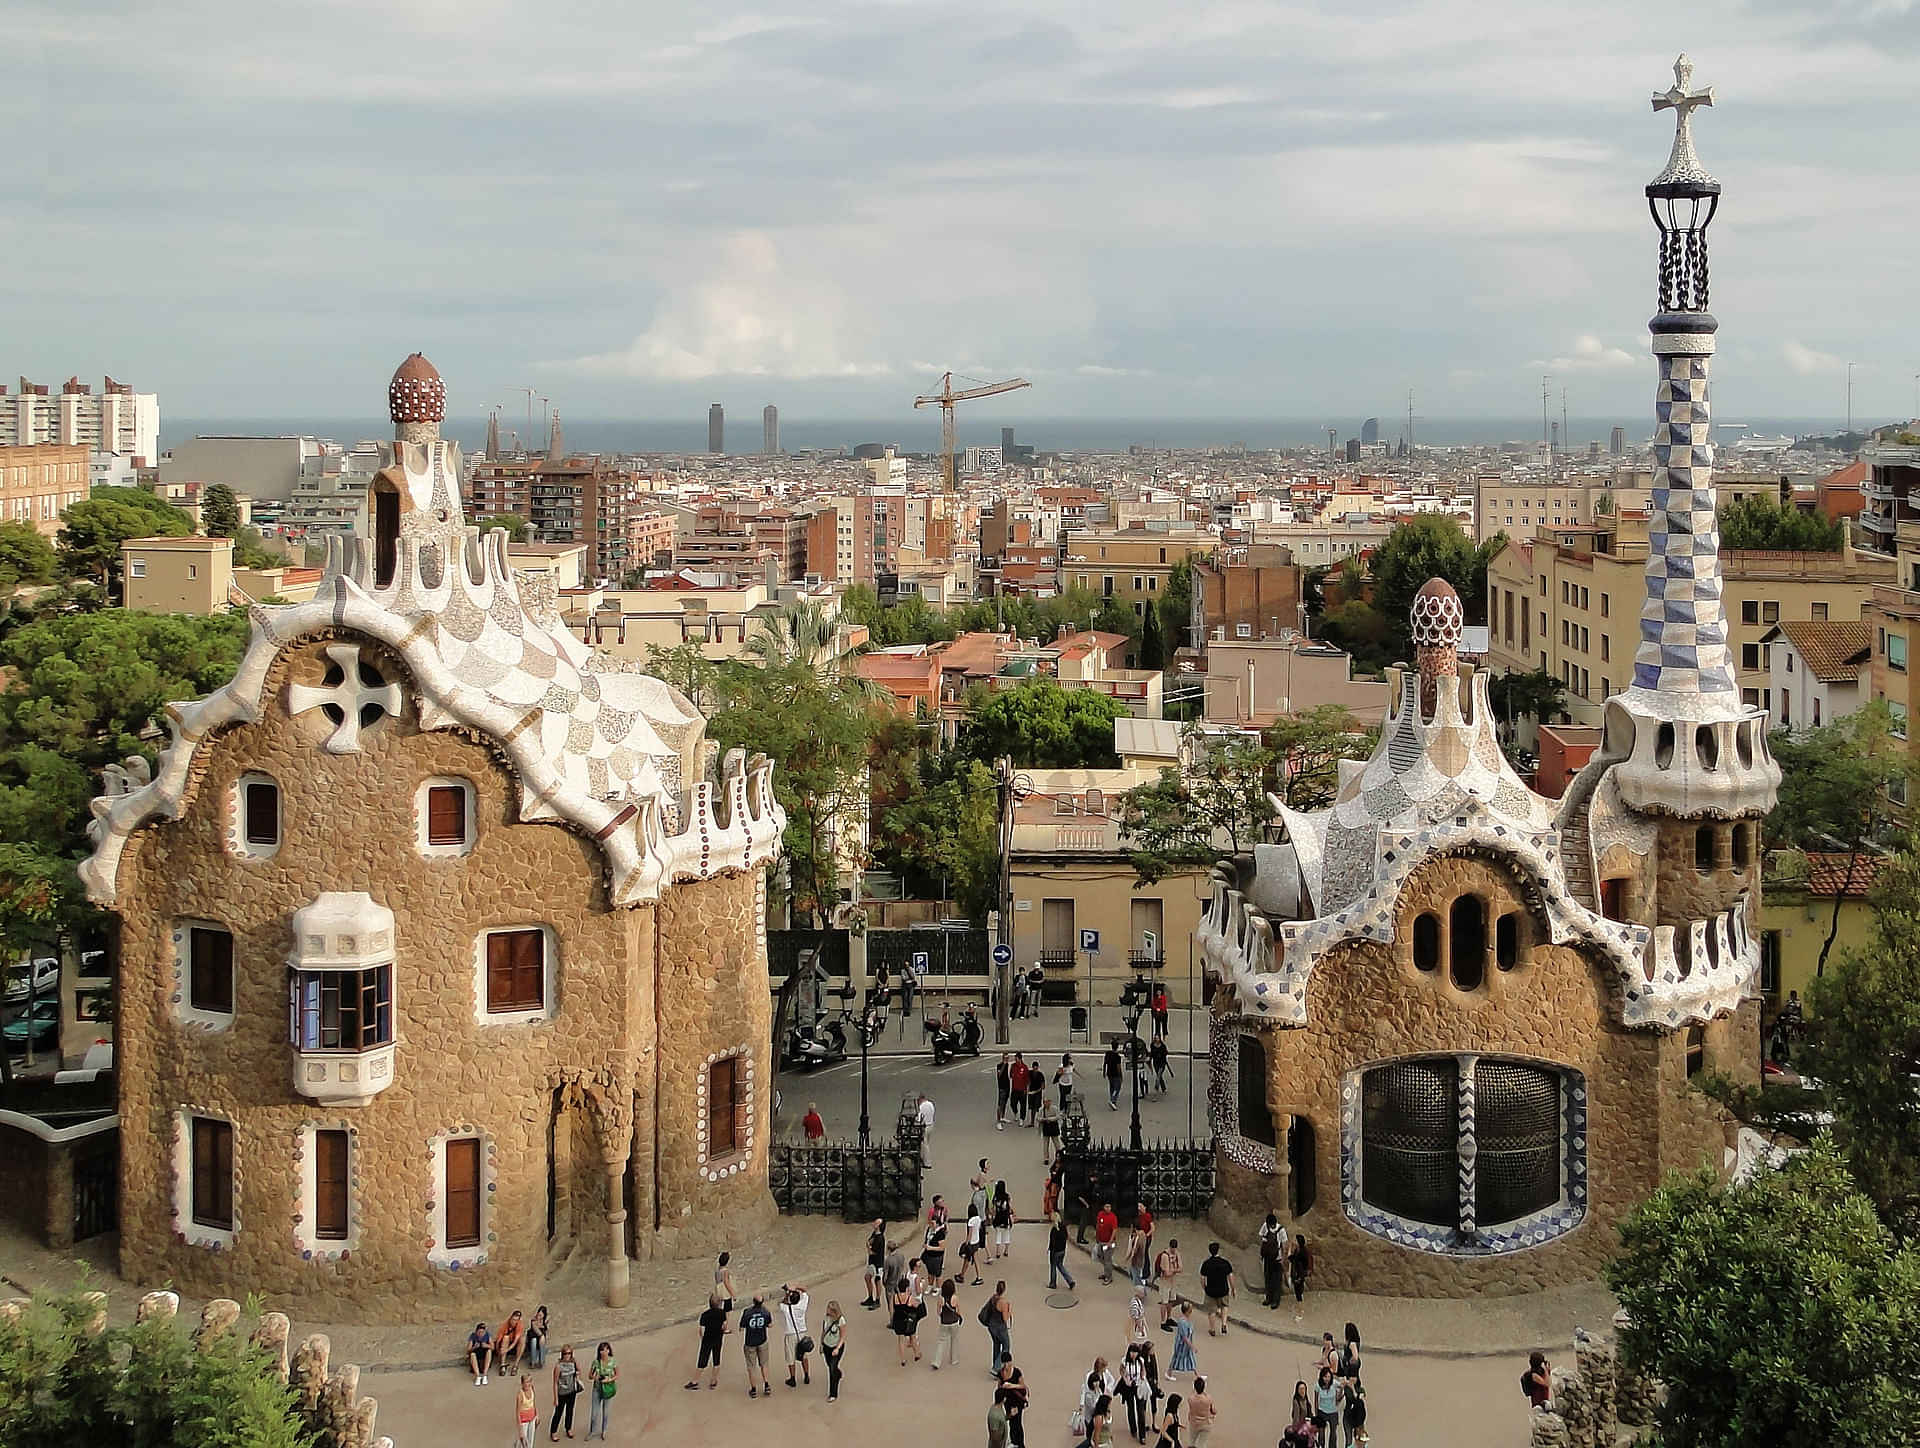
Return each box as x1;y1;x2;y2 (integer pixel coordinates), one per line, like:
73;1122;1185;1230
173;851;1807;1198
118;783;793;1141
0;0;1920;419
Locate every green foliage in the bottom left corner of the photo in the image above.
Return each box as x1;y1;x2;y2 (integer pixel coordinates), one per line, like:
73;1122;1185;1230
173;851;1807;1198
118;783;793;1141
0;1292;314;1448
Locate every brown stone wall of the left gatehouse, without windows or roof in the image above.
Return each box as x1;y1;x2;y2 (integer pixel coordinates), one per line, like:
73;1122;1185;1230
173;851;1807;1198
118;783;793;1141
119;640;772;1319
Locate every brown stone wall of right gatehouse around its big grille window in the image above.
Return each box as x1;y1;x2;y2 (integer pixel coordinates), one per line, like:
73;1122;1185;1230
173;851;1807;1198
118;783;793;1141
1213;841;1722;1296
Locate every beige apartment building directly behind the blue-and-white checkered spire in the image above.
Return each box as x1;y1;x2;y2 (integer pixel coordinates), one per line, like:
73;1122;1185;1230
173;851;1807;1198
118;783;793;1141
1488;515;1893;724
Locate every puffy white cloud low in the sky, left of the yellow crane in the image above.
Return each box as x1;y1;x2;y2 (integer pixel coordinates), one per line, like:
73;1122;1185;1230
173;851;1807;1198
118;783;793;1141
540;230;893;382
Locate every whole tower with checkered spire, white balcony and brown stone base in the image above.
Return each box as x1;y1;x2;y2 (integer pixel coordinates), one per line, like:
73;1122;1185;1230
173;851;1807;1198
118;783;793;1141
1603;56;1780;979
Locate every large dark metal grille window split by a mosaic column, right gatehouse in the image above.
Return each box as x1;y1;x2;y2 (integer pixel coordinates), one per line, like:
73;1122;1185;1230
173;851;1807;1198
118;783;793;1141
1357;1056;1584;1250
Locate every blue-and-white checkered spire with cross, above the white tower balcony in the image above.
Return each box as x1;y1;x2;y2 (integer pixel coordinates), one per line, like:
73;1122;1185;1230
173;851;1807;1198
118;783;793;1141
1634;56;1740;703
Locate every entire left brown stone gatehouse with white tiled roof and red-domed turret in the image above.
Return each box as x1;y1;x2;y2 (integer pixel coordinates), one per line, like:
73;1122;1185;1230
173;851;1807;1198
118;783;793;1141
83;353;783;1317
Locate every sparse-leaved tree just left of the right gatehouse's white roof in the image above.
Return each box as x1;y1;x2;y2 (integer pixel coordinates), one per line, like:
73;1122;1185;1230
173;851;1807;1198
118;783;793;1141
1119;724;1281;885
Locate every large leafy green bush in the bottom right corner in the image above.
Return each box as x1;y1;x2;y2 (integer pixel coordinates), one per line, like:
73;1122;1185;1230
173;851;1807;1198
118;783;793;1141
1605;1146;1920;1448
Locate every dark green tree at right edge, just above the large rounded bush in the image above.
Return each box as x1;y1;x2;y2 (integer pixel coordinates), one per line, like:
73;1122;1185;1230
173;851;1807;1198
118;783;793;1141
1801;841;1920;1239
